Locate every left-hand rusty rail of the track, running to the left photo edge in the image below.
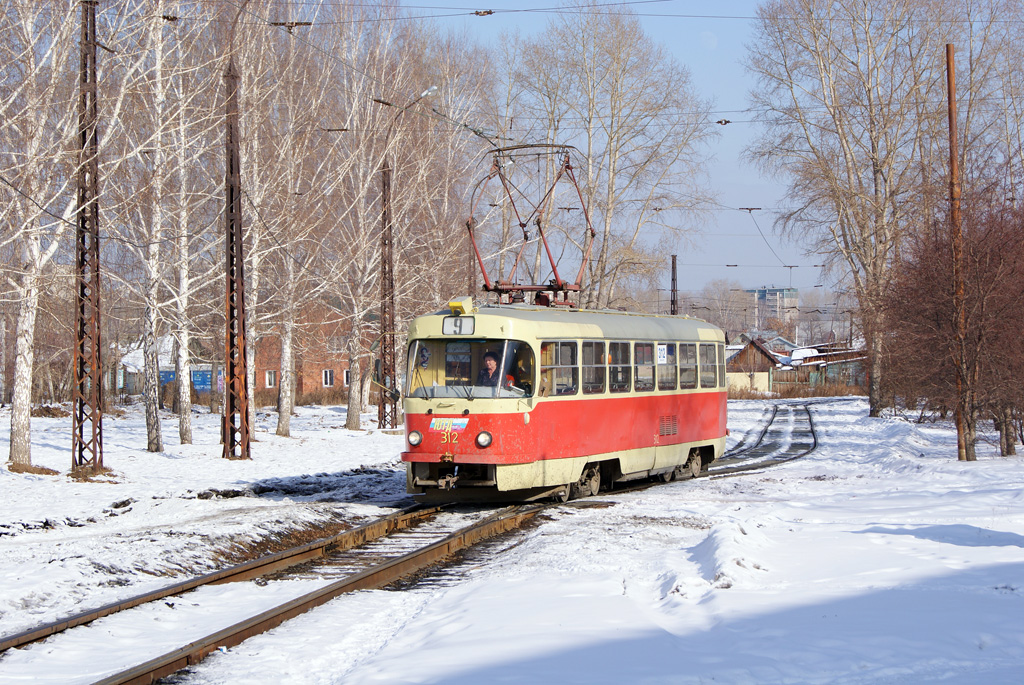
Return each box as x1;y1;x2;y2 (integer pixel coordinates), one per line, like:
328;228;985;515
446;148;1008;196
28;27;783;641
0;504;443;653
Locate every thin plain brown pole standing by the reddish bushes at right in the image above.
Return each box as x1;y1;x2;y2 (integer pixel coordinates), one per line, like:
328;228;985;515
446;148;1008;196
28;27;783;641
946;43;975;462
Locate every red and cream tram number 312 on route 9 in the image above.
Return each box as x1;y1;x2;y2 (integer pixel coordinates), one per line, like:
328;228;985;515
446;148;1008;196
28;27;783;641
402;298;726;501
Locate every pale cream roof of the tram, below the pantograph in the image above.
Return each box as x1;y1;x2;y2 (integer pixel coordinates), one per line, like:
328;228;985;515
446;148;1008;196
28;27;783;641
410;304;725;342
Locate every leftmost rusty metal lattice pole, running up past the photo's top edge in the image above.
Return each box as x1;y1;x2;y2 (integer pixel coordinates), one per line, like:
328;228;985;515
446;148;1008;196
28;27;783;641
72;0;103;473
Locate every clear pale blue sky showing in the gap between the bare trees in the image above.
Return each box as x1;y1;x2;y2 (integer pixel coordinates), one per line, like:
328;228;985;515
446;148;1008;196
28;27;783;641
425;0;829;298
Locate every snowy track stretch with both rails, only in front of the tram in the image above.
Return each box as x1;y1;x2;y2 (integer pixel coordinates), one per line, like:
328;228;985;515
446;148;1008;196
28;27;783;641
0;505;544;683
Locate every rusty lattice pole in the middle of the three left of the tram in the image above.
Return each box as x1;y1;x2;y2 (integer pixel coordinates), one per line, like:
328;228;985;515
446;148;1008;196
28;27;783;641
221;55;251;459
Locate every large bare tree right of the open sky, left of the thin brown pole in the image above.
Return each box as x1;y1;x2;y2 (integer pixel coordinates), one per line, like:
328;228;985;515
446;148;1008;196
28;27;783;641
748;0;944;416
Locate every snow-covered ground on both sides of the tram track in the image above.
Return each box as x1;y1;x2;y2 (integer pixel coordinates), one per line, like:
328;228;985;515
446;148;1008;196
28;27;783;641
0;399;1024;684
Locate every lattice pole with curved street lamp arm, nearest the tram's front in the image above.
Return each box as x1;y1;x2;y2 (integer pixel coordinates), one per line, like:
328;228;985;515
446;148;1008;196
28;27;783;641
376;86;437;428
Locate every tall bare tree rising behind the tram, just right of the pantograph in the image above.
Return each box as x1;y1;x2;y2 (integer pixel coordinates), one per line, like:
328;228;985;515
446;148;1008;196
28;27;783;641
509;3;715;307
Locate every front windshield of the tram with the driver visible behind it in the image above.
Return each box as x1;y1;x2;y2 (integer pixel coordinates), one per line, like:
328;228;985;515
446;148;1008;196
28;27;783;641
406;339;535;399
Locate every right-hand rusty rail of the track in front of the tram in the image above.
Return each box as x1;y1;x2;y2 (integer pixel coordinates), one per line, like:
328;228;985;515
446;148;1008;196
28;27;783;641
96;504;554;685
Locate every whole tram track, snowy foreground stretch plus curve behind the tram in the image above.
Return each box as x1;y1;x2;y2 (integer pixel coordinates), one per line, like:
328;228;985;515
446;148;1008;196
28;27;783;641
0;404;817;683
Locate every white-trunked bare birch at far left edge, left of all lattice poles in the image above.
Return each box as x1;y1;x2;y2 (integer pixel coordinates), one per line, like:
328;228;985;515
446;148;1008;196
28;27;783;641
0;2;79;470
